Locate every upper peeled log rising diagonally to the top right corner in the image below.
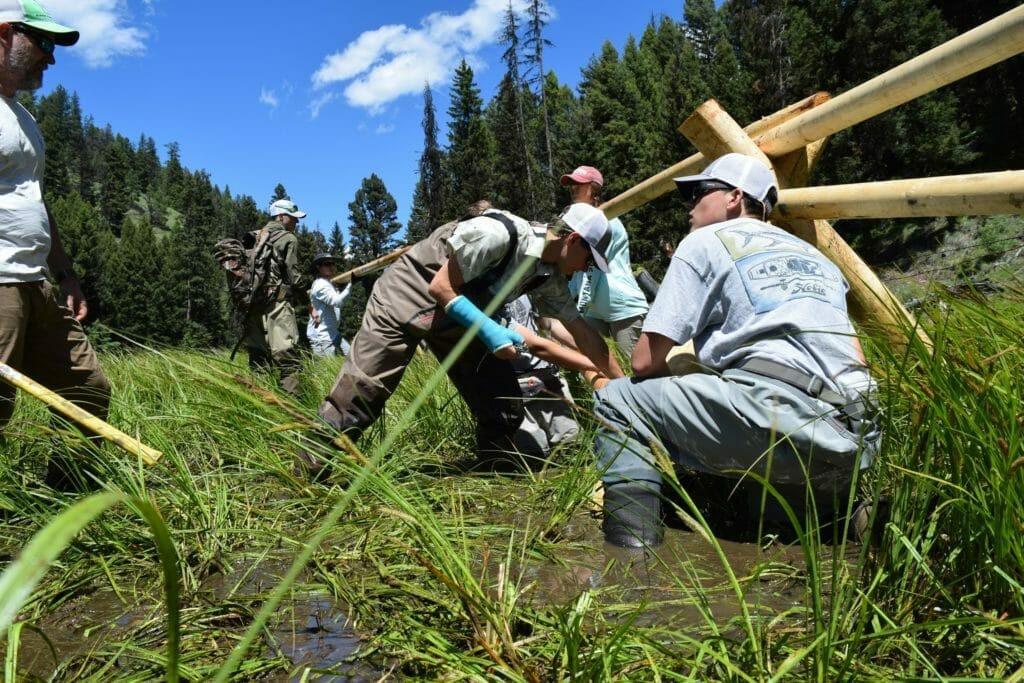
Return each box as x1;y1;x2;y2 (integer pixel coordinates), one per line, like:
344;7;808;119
751;5;1024;158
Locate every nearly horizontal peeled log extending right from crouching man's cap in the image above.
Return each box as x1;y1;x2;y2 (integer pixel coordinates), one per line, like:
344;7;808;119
777;171;1024;219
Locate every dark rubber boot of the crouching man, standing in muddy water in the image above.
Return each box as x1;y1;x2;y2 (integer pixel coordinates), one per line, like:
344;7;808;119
603;481;665;548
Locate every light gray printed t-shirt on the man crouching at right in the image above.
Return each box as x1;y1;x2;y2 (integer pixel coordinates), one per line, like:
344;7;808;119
643;217;867;395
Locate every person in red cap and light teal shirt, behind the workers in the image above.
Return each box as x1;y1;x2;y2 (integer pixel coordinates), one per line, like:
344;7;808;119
559;166;649;356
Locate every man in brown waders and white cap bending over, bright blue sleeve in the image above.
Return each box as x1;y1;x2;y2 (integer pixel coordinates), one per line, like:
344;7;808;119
297;202;623;475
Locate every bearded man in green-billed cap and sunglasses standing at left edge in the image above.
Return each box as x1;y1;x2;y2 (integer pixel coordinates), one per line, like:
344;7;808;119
0;0;111;488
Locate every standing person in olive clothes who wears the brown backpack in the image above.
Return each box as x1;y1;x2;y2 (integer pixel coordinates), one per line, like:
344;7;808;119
243;199;306;395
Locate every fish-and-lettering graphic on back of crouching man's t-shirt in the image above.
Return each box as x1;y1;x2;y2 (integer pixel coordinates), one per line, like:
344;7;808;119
717;226;846;313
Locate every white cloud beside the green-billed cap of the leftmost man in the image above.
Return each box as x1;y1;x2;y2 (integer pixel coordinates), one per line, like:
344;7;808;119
45;0;149;68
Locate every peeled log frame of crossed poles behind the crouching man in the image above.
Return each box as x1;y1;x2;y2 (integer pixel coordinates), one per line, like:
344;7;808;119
601;5;1024;347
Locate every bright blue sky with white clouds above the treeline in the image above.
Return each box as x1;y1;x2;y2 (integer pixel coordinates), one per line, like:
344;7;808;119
40;0;683;233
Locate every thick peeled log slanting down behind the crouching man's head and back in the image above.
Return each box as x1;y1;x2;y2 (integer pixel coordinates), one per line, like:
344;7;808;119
681;100;931;346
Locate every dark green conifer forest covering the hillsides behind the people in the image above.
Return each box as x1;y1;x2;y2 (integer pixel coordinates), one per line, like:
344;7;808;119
25;0;1024;347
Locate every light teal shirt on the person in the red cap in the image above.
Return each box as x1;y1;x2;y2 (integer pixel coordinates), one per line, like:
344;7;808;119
569;218;649;323
